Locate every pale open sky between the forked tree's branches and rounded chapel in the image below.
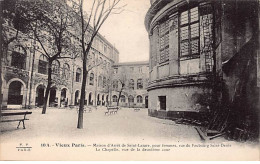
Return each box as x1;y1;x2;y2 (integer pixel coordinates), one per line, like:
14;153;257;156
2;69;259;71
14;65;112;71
94;0;150;62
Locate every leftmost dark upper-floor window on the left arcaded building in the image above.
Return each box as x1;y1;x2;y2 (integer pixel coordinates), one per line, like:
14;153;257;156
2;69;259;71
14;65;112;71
11;51;26;69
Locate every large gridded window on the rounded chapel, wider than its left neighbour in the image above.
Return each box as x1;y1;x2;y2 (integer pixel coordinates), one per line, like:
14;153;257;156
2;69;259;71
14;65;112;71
180;7;199;58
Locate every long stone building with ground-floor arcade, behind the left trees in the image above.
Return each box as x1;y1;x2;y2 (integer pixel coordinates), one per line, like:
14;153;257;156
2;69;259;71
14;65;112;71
1;15;119;108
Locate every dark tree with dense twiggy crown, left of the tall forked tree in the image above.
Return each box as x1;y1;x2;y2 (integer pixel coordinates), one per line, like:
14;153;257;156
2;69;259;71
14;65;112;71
15;0;78;114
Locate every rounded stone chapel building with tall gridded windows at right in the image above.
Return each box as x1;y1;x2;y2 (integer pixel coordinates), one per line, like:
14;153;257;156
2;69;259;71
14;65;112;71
145;0;259;132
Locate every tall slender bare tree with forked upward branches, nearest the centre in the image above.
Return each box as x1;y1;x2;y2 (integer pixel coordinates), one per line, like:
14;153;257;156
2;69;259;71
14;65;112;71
74;0;123;129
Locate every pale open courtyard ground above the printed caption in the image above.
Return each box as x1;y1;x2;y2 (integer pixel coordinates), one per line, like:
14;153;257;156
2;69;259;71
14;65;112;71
1;107;200;142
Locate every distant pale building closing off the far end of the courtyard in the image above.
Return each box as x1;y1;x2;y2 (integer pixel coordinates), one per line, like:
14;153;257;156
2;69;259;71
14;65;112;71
110;61;149;108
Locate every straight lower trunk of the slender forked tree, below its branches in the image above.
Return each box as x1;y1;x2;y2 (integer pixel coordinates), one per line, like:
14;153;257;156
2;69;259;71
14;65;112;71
77;54;88;129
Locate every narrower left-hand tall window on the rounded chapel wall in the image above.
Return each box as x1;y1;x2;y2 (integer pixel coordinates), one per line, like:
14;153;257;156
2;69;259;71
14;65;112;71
159;20;170;63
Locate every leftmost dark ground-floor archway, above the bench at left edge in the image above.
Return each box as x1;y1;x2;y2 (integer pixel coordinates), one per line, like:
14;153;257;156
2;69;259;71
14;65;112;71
7;81;23;105
